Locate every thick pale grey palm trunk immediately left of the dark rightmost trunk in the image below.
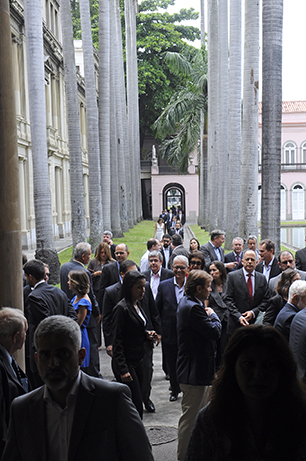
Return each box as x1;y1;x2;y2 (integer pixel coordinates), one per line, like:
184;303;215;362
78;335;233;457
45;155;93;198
239;0;259;240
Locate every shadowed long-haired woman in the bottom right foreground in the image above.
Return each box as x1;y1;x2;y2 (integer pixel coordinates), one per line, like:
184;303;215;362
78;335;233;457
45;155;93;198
186;325;306;461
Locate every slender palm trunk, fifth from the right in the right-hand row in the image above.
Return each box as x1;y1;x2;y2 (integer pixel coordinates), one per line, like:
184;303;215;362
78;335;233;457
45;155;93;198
207;0;219;231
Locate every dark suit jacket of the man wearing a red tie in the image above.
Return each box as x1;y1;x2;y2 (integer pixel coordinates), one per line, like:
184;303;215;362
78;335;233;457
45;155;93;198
224;269;270;335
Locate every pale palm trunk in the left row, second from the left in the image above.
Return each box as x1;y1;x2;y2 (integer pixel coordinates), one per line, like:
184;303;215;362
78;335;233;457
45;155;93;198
60;0;86;247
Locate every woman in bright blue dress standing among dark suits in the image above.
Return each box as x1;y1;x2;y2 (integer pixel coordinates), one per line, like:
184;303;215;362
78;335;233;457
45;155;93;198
68;270;92;368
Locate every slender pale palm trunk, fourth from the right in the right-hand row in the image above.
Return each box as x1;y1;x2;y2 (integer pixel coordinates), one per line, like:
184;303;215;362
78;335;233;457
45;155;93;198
218;0;228;229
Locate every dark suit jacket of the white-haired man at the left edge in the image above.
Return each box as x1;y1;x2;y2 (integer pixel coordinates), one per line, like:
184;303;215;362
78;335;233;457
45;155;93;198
0;349;26;458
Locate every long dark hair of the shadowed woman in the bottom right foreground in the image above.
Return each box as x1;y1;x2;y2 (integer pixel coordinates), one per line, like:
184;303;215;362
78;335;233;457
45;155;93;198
209;325;306;434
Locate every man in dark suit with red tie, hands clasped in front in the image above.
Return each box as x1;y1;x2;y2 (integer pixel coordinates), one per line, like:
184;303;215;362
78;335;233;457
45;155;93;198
224;250;270;335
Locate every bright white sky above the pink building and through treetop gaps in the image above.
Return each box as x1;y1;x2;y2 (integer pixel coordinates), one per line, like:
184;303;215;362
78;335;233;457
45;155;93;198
163;0;306;101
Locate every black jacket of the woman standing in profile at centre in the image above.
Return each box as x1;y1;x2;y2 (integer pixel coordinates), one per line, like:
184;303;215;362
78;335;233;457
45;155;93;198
112;299;148;375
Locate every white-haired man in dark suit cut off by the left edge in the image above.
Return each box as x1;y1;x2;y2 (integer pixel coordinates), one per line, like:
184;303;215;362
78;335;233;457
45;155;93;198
0;307;28;458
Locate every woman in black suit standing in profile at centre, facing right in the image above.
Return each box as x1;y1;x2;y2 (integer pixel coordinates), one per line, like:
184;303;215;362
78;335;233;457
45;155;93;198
112;270;158;418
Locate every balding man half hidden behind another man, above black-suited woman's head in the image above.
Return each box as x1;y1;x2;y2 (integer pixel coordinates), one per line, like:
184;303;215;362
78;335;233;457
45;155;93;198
98;243;130;312
